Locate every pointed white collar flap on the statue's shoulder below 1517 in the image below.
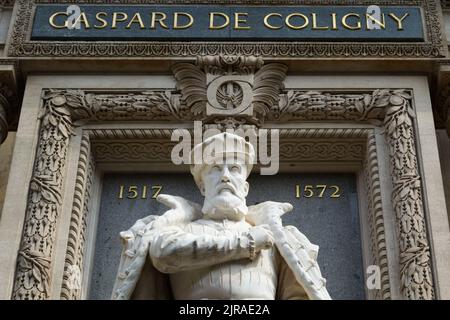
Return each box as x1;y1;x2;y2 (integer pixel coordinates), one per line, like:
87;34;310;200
156;194;202;228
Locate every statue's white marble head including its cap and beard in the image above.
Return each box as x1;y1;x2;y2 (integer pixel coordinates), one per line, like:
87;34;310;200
191;133;255;220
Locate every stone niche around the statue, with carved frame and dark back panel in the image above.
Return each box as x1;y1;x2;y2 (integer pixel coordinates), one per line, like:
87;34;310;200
0;56;450;299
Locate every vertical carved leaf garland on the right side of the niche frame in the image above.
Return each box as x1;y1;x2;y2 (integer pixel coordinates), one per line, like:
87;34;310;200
383;90;435;300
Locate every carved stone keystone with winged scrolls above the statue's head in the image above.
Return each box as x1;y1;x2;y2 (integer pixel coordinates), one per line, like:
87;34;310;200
173;56;287;122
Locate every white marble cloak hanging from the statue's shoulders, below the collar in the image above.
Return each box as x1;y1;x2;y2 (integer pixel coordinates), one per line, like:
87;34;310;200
111;202;329;300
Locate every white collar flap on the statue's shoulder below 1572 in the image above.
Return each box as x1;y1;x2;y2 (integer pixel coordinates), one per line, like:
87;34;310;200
246;201;294;226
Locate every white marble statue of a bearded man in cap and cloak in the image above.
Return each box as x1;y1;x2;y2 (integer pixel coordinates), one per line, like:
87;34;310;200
112;133;331;300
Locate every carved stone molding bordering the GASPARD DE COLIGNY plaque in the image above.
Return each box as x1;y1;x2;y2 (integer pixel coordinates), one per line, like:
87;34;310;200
8;0;447;59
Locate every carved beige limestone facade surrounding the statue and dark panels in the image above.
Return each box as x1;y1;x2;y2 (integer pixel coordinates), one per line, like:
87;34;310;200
0;0;450;299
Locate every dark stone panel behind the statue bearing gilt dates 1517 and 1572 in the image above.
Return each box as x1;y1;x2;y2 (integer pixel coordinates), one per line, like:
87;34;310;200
89;173;365;299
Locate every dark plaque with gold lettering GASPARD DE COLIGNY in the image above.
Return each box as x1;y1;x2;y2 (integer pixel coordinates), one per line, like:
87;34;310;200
31;4;424;42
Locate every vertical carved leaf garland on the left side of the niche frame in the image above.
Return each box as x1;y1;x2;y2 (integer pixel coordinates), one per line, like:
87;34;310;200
12;91;73;300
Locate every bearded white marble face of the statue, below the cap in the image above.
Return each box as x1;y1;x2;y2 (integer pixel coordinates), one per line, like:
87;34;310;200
201;158;249;220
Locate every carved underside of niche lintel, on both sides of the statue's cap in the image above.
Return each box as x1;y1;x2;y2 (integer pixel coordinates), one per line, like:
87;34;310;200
90;129;367;163
